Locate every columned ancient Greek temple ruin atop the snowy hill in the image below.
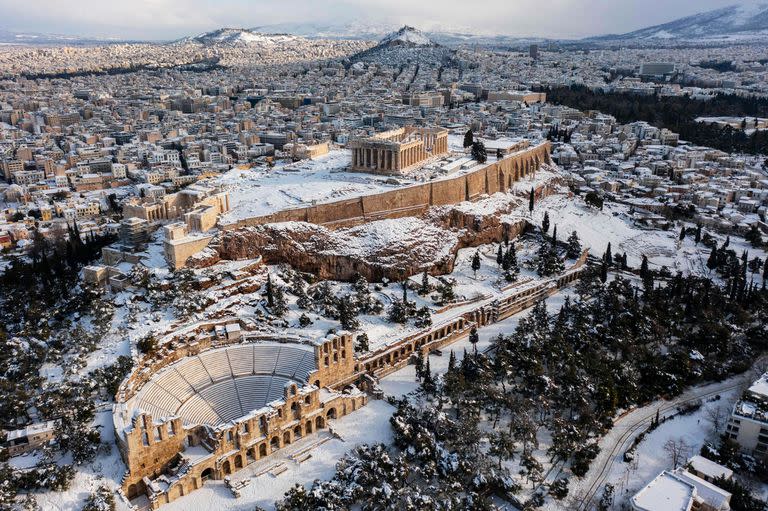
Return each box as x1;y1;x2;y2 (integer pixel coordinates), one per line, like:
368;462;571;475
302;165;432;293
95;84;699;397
349;126;448;174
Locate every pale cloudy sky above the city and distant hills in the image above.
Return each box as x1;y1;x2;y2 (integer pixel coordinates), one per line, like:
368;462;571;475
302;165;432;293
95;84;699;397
0;0;752;40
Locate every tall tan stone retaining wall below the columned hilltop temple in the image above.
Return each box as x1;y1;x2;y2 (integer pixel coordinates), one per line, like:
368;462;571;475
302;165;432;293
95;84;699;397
221;142;551;230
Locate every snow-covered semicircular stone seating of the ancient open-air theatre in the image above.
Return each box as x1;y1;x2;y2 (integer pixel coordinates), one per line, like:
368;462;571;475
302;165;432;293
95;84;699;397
133;343;317;426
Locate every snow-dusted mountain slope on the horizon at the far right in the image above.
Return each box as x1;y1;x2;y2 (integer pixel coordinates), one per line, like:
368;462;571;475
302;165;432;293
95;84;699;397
594;0;768;40
